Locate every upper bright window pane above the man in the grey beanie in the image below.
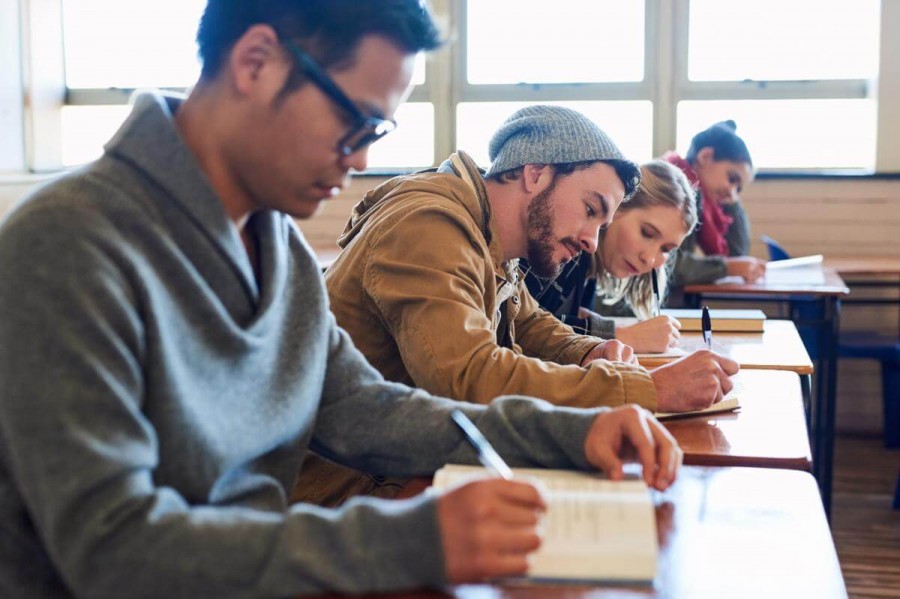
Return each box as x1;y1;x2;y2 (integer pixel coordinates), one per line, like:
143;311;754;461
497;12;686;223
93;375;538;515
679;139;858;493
466;0;644;83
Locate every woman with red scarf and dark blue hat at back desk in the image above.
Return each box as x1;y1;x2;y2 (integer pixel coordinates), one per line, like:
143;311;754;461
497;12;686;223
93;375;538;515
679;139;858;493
663;121;766;286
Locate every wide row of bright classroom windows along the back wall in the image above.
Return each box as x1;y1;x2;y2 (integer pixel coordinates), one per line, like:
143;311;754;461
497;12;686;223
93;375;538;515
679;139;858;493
10;0;900;171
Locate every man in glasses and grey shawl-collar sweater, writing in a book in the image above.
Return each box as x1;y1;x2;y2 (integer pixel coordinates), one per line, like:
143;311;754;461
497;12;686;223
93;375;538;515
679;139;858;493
0;0;680;598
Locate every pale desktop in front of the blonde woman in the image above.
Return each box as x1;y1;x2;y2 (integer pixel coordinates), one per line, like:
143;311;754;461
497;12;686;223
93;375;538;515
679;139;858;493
639;320;813;374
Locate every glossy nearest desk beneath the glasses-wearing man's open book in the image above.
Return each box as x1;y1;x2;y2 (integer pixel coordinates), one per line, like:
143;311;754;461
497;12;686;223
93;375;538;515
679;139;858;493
328;466;847;599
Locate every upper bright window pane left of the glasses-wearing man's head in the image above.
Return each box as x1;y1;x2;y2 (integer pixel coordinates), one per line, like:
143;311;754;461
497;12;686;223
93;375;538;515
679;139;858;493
63;0;206;88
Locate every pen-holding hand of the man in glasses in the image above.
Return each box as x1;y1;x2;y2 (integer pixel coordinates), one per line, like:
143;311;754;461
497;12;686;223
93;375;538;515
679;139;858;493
437;478;547;584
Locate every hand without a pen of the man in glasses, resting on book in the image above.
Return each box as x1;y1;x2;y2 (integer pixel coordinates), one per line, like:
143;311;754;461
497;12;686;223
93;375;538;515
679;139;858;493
584;404;683;491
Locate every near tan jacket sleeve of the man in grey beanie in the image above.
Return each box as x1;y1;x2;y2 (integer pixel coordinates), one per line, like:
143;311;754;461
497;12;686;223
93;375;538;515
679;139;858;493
363;202;656;409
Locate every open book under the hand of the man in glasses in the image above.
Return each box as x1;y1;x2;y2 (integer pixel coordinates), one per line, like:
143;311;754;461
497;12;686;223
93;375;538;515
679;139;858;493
433;464;659;582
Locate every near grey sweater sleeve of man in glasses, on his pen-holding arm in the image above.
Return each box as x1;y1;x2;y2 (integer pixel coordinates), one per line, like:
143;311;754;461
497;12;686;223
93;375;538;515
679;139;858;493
0;205;443;598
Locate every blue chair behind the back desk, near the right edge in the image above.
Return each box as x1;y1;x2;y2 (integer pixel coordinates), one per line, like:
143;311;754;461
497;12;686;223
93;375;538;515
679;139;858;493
760;235;900;448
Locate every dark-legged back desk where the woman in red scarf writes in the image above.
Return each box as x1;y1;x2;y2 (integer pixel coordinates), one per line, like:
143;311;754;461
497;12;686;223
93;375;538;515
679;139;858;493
684;266;849;514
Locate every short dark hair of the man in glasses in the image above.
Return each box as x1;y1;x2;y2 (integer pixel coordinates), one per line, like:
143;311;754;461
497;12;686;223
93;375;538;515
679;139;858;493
197;0;441;86
